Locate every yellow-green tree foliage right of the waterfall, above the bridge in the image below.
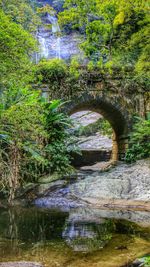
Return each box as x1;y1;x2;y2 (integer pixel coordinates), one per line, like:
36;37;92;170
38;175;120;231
59;0;150;79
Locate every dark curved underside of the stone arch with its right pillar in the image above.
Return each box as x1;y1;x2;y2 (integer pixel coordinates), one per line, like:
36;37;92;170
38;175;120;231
64;93;131;160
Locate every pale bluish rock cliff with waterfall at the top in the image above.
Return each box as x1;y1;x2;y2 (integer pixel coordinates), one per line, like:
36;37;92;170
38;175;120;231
36;0;83;62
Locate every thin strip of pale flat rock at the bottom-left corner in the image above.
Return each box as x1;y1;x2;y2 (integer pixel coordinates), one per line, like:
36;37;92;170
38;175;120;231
0;261;43;267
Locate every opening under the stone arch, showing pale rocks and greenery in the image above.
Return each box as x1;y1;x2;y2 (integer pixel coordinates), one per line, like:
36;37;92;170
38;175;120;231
71;110;113;170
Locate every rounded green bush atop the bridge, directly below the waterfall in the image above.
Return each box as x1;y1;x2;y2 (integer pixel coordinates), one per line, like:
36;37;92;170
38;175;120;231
35;58;81;99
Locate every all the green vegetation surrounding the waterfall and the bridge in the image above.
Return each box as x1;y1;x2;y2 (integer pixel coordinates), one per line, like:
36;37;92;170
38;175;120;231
0;0;150;201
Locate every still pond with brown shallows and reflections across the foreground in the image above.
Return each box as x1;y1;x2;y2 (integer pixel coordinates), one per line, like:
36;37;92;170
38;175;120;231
0;207;150;267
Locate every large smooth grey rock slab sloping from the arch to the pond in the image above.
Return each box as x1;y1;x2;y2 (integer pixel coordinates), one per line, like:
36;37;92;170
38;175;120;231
29;159;150;214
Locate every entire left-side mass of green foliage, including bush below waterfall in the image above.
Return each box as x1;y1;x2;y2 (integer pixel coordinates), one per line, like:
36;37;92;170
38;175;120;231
0;0;77;202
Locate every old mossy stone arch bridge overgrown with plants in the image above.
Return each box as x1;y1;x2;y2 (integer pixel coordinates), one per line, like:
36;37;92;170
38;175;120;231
38;69;150;160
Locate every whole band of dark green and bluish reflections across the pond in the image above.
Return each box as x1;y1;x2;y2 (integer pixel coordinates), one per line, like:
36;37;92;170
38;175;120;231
0;207;150;257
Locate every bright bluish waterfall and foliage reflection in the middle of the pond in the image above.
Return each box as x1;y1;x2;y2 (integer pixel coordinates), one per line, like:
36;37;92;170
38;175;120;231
63;220;114;252
